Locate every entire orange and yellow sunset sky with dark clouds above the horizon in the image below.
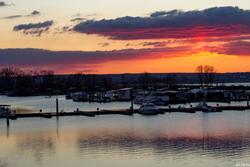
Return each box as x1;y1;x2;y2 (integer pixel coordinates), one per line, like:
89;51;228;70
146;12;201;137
0;0;250;74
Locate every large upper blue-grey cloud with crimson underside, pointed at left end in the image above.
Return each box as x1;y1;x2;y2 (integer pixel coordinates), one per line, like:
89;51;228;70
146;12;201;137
73;7;250;40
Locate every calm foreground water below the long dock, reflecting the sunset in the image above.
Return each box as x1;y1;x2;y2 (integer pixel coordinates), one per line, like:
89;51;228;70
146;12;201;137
0;97;250;167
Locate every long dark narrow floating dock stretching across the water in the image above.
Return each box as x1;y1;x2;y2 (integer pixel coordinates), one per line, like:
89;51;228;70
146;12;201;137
1;100;250;120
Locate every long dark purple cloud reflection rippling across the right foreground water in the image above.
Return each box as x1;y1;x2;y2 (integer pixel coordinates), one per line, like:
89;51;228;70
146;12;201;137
77;129;250;158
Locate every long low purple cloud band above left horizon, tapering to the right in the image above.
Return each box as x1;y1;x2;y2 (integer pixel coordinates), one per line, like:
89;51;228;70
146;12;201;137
0;47;188;72
